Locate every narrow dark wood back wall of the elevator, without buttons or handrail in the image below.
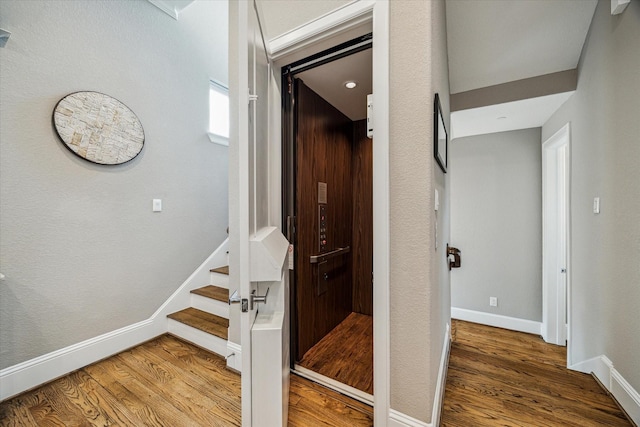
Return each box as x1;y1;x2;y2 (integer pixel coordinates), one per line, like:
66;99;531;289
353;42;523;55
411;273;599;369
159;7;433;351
351;120;373;316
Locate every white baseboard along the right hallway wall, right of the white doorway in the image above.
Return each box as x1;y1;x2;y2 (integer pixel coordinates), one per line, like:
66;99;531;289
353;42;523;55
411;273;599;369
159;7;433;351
569;355;640;425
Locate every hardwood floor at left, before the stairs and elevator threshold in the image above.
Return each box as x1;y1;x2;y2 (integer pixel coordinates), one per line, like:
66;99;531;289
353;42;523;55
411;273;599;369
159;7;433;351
0;335;373;427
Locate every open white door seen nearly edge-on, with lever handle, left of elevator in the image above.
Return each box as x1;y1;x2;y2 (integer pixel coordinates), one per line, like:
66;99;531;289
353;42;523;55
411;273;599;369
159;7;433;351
229;1;270;427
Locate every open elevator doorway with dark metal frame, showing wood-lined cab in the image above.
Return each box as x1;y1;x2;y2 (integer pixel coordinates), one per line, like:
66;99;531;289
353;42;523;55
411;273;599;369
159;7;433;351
283;35;373;404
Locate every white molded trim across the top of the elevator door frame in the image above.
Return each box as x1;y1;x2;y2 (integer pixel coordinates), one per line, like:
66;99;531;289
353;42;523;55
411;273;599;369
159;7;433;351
268;0;375;61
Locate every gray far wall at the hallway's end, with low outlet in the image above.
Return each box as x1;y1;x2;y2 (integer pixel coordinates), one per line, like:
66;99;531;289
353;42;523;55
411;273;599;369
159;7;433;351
451;128;542;322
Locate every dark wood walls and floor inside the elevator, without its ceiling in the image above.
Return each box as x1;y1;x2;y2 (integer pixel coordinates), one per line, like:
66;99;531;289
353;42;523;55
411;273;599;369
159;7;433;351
290;67;373;395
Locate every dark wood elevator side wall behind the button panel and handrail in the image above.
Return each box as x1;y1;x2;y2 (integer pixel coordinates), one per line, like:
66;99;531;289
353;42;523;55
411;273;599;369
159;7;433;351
295;80;353;360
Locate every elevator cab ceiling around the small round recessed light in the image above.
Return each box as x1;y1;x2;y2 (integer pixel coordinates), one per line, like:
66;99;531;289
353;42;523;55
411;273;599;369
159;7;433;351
297;49;373;121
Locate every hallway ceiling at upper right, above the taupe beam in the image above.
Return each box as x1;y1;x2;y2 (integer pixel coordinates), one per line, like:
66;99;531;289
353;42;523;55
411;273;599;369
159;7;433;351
446;0;597;93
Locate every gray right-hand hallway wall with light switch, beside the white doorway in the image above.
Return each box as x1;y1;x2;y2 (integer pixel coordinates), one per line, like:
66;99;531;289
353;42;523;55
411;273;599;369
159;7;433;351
542;0;640;390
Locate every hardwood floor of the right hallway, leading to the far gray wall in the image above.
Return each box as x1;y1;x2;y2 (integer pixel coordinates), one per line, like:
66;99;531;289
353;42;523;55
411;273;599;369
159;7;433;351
441;320;632;427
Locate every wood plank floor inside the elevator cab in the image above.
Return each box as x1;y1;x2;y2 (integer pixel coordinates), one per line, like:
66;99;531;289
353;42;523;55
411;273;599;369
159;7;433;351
298;313;373;394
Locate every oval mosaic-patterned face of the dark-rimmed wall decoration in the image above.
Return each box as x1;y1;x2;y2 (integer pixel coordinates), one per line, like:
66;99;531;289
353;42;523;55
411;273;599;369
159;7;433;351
53;92;144;165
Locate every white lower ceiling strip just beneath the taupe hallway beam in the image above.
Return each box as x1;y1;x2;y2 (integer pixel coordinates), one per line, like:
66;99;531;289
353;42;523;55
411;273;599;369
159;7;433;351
451;91;575;140
